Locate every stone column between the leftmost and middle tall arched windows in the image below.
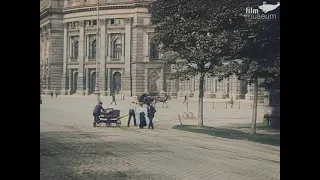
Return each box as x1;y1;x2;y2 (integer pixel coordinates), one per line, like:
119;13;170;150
77;21;85;96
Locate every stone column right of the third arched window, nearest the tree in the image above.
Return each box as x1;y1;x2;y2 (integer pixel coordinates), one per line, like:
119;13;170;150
122;18;132;96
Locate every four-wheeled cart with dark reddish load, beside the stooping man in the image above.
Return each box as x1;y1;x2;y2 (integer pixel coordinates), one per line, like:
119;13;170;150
97;108;121;127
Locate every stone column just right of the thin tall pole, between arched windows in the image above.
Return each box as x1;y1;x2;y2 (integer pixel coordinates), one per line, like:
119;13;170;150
99;19;107;96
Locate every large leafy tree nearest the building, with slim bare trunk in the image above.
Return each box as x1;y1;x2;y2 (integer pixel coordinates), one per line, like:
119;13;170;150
149;0;241;127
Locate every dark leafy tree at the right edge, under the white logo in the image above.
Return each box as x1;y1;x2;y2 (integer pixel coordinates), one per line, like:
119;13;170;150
215;1;280;134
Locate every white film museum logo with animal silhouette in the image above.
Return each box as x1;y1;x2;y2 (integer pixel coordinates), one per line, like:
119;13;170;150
245;2;280;20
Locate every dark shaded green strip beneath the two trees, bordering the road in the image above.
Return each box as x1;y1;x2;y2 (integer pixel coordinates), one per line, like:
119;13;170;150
172;125;280;146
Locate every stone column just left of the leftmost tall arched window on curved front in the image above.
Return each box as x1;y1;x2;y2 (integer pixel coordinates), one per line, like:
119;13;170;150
61;23;68;95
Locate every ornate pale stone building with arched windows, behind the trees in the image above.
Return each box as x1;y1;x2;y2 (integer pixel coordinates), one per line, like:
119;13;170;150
40;0;264;99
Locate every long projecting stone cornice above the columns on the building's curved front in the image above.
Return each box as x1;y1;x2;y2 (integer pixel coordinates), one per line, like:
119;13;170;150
62;4;149;14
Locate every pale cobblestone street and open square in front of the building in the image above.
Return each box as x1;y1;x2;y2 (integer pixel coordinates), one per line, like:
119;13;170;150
40;97;280;180
